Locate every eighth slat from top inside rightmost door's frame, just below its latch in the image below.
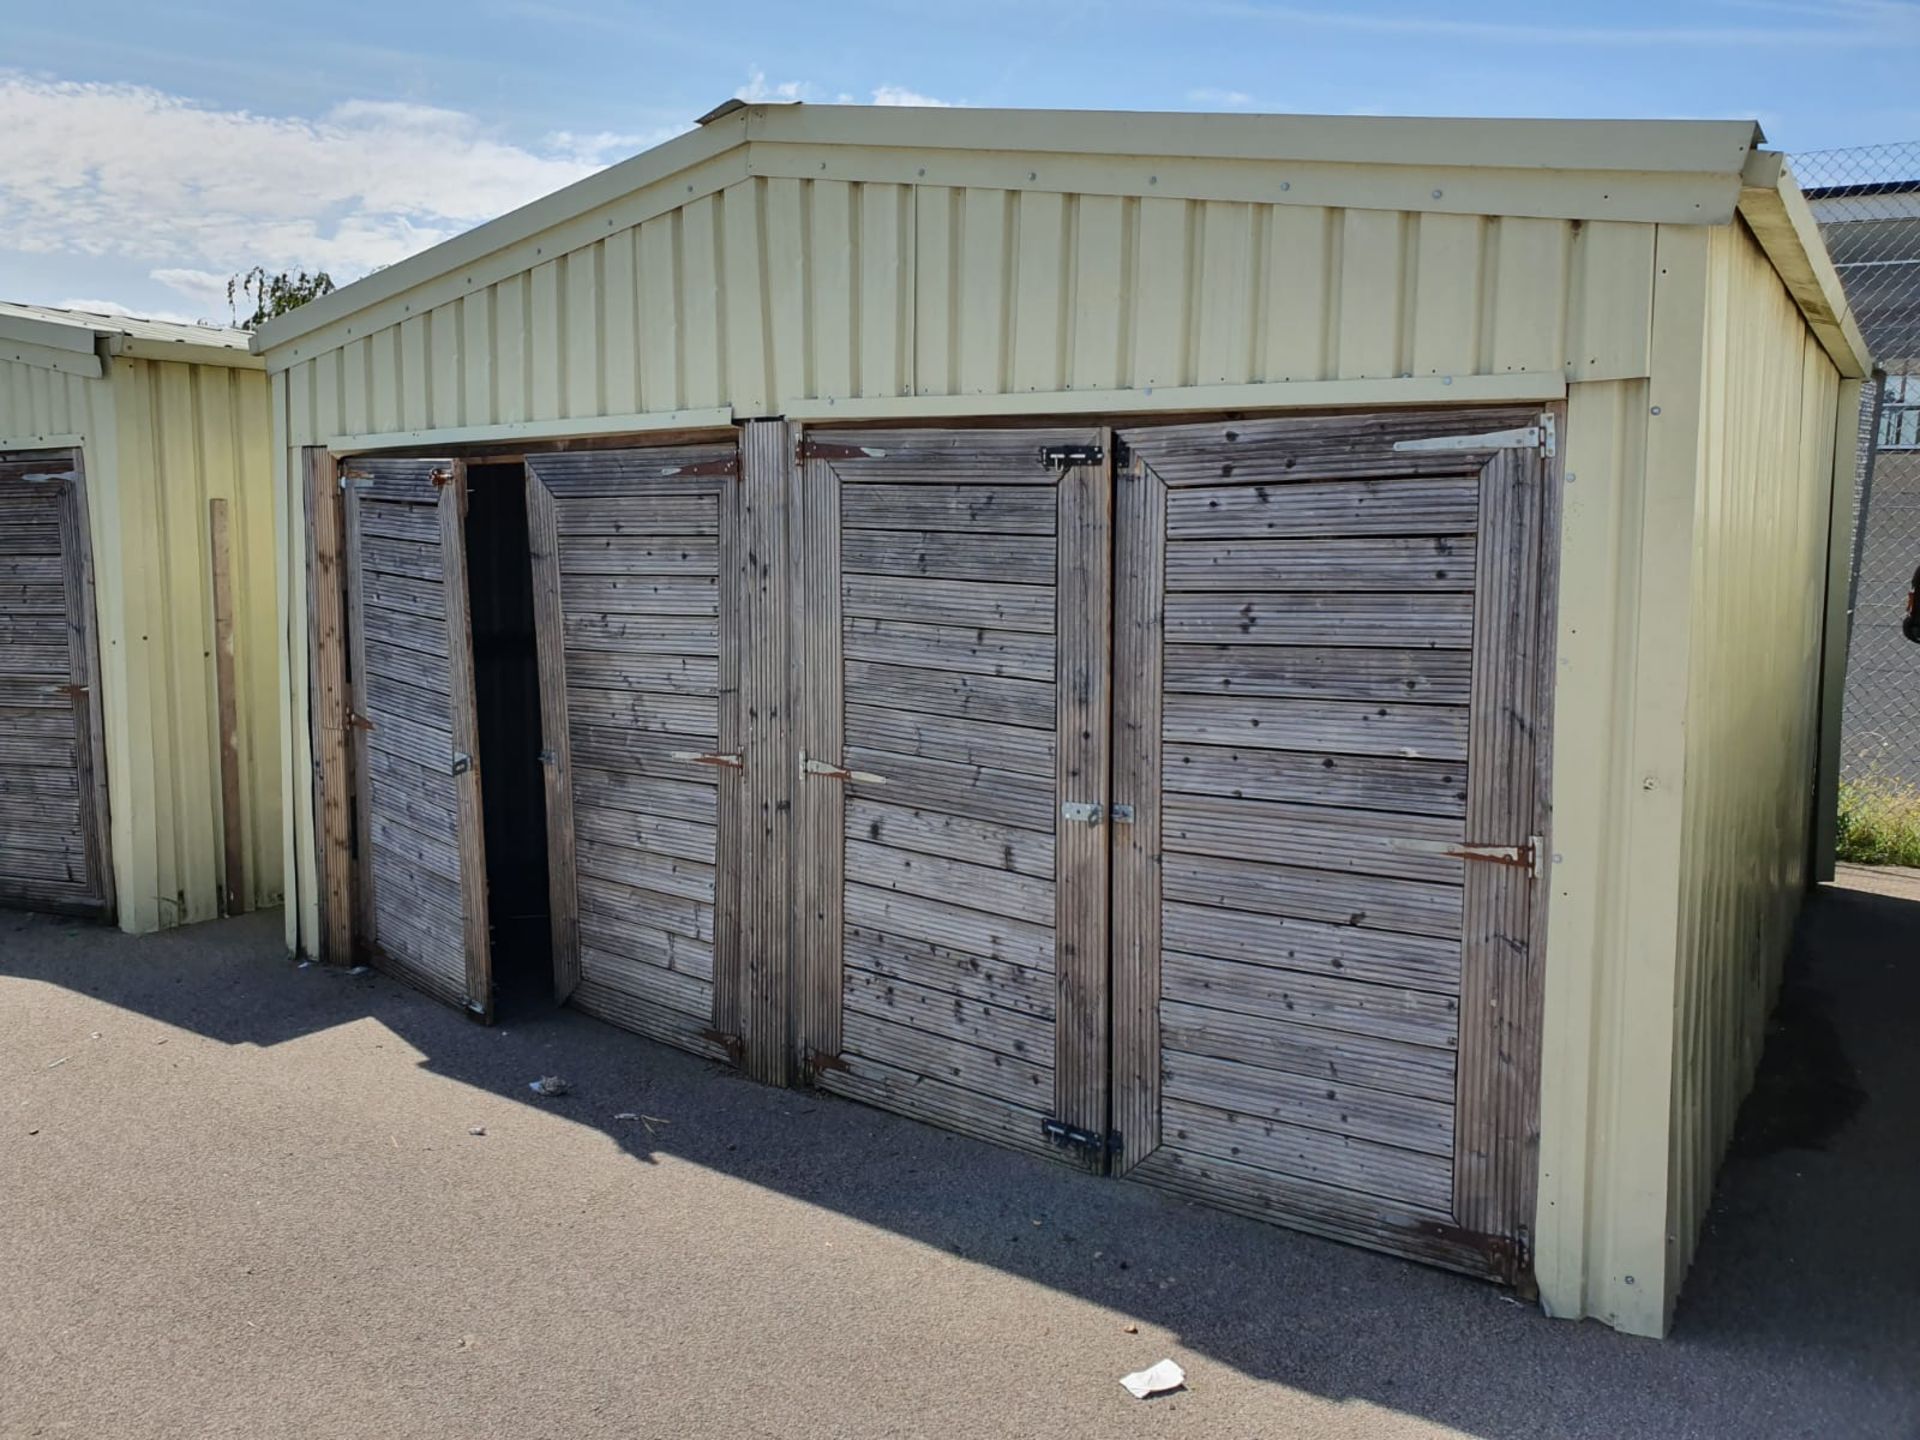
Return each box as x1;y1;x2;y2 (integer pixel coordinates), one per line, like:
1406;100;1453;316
1162;851;1461;939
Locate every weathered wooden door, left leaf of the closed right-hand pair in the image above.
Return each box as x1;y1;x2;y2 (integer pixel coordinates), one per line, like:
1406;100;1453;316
789;430;1112;1167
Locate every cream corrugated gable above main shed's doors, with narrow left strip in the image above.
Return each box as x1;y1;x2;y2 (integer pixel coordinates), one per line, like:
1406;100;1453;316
275;177;1655;948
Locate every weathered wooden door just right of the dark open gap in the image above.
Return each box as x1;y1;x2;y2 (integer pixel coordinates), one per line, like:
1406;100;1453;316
526;444;748;1058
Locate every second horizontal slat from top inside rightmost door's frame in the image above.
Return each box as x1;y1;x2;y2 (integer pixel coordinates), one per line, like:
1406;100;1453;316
1167;536;1473;593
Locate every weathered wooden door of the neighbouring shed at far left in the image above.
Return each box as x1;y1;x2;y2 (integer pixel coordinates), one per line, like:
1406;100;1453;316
0;449;113;918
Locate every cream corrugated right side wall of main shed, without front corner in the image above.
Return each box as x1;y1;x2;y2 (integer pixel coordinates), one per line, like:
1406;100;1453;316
1668;225;1839;1292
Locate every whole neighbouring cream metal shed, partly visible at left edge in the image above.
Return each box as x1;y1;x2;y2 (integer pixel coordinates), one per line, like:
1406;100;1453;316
0;303;286;931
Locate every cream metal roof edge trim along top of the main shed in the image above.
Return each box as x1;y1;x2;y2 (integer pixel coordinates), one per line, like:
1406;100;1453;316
253;104;1866;374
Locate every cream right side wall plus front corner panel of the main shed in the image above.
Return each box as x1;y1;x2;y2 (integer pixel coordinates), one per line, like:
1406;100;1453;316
1536;223;1839;1334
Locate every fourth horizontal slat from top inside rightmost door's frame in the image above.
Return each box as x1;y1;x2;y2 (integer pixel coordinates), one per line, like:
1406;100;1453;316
1162;645;1473;705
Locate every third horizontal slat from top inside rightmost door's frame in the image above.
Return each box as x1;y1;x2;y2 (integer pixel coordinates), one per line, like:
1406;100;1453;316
1165;591;1473;649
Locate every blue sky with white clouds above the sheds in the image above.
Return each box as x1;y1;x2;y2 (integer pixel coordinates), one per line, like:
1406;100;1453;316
0;0;1920;319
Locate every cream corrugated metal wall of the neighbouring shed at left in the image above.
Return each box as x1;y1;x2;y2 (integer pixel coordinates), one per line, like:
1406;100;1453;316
0;357;284;931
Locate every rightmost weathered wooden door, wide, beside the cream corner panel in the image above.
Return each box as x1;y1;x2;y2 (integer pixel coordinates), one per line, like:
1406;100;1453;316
1114;411;1551;1279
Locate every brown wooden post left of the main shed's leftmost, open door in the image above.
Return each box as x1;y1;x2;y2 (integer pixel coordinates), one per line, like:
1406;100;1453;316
303;445;353;966
